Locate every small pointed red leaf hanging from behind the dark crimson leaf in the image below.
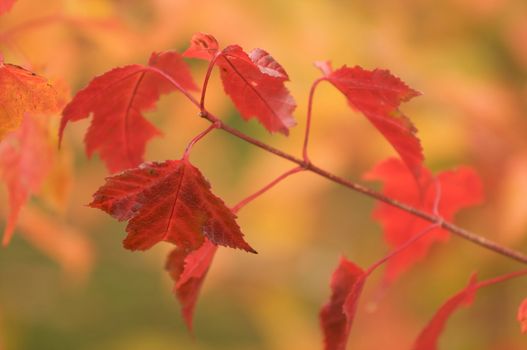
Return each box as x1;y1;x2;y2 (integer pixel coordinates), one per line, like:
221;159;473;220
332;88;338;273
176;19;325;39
165;239;217;330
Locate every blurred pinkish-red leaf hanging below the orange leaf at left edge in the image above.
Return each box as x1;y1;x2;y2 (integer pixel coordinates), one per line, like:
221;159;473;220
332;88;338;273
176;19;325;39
0;113;54;245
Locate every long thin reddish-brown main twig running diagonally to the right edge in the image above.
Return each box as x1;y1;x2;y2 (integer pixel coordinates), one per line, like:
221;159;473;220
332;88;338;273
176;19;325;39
145;67;527;264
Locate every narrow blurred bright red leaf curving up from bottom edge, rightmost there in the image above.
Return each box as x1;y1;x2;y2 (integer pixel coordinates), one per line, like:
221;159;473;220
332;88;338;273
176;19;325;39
413;274;479;350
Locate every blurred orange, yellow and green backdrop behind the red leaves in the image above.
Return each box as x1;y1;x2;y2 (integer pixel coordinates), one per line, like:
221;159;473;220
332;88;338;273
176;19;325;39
0;0;527;350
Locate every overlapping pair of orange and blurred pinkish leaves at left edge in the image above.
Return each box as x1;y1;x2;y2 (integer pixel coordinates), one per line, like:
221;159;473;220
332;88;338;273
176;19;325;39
0;55;63;245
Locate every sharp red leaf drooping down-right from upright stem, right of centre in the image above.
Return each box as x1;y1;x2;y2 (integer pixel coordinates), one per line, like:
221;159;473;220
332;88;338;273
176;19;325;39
316;62;424;178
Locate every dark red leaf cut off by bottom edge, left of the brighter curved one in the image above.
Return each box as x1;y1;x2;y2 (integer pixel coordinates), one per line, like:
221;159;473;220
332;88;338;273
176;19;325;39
320;257;366;350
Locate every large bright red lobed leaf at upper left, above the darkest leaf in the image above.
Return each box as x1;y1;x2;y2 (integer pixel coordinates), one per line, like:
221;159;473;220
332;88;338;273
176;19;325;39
59;52;197;172
